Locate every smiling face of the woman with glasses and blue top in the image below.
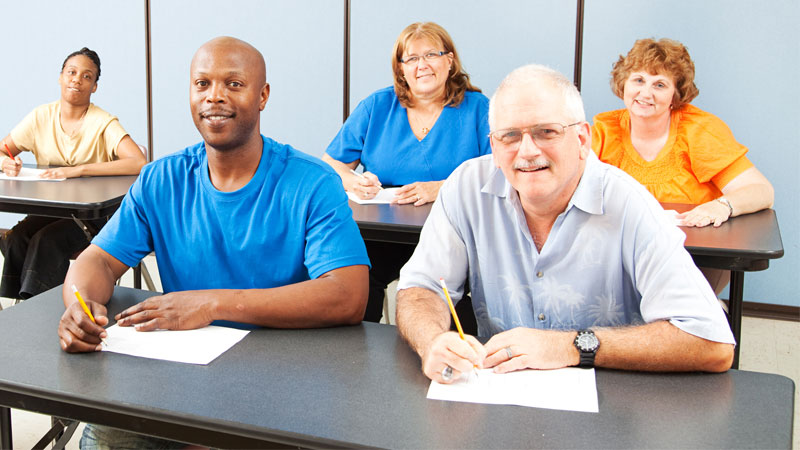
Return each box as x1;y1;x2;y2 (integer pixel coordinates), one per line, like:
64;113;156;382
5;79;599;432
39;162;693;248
400;39;453;98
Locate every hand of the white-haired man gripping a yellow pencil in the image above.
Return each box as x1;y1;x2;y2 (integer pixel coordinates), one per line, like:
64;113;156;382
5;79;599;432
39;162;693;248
422;331;486;384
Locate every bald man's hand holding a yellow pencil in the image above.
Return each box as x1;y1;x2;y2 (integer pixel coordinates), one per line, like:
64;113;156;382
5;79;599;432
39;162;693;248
58;301;108;353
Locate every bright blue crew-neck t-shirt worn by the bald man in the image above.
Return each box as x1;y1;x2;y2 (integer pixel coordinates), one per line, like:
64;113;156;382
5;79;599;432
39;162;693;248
92;136;369;292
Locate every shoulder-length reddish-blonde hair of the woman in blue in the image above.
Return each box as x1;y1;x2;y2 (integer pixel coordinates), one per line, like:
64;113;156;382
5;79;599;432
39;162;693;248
392;22;481;108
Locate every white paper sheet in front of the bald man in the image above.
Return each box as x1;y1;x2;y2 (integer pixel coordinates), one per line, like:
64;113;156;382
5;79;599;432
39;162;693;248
103;324;250;365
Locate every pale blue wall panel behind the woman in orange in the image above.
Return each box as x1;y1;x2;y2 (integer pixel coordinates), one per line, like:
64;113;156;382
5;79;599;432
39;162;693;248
582;0;800;306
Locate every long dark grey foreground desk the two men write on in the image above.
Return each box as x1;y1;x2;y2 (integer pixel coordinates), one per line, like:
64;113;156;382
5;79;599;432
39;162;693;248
0;287;794;448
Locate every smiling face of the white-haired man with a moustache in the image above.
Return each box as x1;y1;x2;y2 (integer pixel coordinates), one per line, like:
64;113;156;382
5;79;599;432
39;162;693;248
491;81;591;212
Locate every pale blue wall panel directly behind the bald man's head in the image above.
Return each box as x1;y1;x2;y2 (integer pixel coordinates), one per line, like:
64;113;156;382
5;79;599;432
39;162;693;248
151;0;344;158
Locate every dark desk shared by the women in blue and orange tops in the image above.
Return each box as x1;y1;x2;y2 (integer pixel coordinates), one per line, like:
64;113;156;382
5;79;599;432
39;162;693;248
350;201;783;368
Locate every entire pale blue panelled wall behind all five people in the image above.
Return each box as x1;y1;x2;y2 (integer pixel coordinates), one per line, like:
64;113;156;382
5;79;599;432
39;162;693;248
0;0;800;306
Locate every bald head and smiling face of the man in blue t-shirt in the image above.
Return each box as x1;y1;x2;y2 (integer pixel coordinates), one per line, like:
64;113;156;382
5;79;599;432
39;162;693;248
189;38;269;151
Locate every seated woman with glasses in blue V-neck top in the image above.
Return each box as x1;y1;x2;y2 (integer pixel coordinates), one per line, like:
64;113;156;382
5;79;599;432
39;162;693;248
322;22;491;322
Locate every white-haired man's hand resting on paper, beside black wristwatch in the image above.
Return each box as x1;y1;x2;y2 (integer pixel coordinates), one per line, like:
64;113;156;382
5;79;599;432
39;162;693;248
483;328;580;373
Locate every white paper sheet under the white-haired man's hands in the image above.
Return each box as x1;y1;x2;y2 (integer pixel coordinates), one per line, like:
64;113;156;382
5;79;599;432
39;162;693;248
428;367;599;413
